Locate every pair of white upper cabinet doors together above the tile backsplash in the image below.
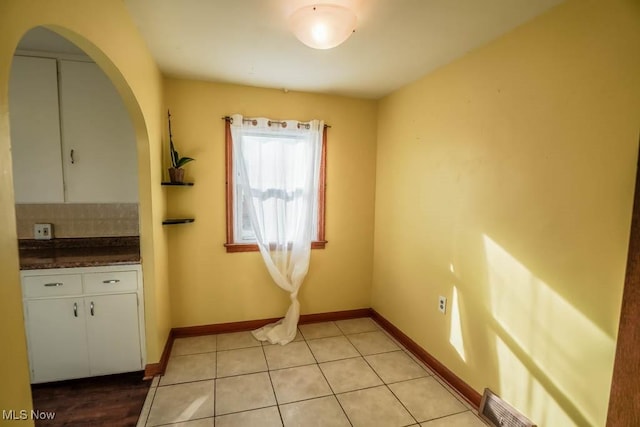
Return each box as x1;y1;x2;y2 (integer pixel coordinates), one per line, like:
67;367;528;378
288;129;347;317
9;56;138;203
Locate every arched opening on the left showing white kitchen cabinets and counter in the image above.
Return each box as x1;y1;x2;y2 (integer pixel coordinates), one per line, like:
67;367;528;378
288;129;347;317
9;27;146;406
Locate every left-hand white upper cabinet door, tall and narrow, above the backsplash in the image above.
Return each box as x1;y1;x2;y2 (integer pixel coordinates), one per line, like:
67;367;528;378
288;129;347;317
9;56;64;203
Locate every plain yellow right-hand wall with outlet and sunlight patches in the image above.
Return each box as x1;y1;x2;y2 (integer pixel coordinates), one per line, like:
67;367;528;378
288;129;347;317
372;0;640;426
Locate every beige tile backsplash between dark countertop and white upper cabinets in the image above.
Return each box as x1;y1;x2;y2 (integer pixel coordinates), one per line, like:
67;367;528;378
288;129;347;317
16;203;140;239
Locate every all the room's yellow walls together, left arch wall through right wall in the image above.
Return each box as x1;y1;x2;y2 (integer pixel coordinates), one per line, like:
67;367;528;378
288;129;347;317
0;0;640;426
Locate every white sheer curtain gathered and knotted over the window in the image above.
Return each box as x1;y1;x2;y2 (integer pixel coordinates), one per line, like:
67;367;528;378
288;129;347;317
231;114;324;345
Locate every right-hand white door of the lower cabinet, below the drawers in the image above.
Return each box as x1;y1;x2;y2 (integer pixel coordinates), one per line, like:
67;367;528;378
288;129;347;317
84;294;143;375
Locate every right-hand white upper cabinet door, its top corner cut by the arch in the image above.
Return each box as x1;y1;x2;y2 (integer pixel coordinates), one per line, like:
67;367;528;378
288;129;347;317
60;60;138;203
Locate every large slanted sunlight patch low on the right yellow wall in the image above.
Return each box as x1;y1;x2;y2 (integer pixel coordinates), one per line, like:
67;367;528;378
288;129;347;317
484;235;615;425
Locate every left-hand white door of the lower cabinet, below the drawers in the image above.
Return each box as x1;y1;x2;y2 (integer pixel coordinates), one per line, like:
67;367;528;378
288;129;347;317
25;298;90;383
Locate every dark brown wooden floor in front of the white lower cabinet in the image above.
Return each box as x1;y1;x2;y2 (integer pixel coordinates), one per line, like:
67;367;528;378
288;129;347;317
31;371;151;427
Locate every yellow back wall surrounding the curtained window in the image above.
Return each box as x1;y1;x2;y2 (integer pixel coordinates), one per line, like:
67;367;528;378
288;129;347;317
165;79;376;326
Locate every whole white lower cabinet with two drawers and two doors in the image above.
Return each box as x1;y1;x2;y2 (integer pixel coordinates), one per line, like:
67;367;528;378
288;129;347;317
21;265;145;383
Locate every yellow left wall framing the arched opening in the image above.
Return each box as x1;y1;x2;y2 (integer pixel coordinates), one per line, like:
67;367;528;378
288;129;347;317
0;0;171;416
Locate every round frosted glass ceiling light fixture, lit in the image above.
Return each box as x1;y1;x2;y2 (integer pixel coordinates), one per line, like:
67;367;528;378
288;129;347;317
289;4;357;49
